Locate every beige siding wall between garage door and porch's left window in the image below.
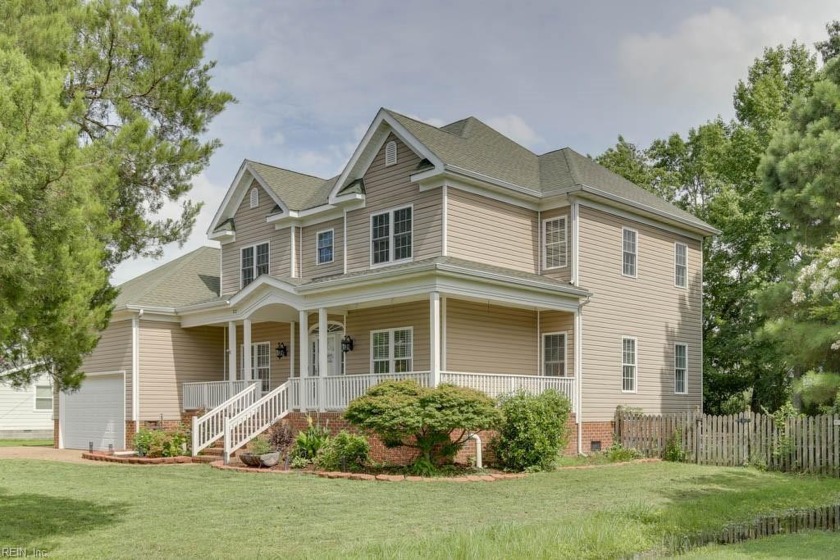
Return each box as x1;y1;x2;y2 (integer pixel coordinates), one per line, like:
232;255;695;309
139;320;223;420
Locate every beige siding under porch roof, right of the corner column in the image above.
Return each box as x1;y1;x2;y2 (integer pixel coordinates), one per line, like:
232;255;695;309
446;298;539;375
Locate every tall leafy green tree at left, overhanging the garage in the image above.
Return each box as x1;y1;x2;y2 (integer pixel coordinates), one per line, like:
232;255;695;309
0;0;232;389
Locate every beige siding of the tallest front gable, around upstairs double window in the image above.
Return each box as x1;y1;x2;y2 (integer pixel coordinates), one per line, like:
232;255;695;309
347;134;443;272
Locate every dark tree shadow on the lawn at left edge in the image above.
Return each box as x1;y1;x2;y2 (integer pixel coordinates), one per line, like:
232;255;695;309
0;492;127;548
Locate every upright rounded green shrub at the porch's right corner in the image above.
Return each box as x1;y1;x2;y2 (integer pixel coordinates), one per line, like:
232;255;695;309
490;390;572;471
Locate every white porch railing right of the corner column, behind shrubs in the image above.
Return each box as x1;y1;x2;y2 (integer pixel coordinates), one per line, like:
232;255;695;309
440;371;577;412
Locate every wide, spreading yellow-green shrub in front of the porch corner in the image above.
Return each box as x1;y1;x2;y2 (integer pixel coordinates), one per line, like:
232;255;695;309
344;380;500;467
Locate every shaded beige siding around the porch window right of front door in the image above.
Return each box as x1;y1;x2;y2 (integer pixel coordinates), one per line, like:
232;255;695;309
345;300;429;374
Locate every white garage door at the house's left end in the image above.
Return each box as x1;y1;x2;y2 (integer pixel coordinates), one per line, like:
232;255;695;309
60;373;125;449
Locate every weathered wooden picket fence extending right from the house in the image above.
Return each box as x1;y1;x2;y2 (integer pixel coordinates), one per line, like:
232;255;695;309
616;411;840;476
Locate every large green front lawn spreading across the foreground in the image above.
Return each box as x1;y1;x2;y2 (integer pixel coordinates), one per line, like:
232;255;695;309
0;460;840;559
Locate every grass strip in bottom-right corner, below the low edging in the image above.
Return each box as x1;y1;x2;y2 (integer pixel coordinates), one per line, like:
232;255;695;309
680;531;840;560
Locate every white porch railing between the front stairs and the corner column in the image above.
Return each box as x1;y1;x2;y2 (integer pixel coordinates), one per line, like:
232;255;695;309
289;371;432;410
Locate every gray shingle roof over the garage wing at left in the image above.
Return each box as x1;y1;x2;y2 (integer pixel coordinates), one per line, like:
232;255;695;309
115;247;221;309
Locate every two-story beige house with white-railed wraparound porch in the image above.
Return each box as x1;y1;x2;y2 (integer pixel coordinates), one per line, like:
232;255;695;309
56;109;715;460
